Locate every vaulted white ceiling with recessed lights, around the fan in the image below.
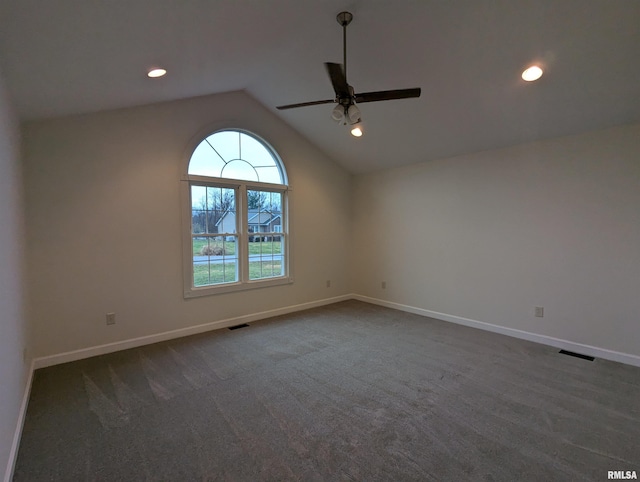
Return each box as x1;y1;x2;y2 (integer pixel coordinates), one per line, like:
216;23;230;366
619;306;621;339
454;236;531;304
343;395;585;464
0;0;640;172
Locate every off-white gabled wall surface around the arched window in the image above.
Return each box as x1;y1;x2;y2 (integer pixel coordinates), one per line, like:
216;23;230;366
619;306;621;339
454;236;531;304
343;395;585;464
23;92;351;357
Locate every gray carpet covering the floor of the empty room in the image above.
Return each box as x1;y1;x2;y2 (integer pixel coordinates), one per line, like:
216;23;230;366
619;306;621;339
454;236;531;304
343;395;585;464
14;301;640;482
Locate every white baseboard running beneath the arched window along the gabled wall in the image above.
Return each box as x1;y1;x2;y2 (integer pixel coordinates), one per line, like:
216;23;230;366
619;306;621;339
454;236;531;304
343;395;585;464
33;295;352;369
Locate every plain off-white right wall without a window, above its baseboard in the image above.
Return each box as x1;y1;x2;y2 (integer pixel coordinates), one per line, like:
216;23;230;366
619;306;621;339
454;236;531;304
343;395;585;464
352;125;640;356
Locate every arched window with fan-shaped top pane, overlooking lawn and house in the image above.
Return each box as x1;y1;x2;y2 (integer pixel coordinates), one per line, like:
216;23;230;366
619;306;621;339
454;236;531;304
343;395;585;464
183;129;291;297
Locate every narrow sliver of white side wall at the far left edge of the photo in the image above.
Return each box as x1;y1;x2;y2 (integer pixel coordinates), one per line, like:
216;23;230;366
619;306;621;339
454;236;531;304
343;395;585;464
0;67;27;477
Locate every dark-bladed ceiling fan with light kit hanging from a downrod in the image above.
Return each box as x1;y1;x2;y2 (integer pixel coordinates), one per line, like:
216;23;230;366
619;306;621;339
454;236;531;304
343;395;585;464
276;12;420;136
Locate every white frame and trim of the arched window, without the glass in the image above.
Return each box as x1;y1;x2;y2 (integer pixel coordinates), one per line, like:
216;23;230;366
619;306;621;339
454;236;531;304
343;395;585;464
181;129;293;298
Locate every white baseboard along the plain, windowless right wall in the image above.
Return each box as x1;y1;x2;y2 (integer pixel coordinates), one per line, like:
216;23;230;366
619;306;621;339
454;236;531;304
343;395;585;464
352;294;640;367
